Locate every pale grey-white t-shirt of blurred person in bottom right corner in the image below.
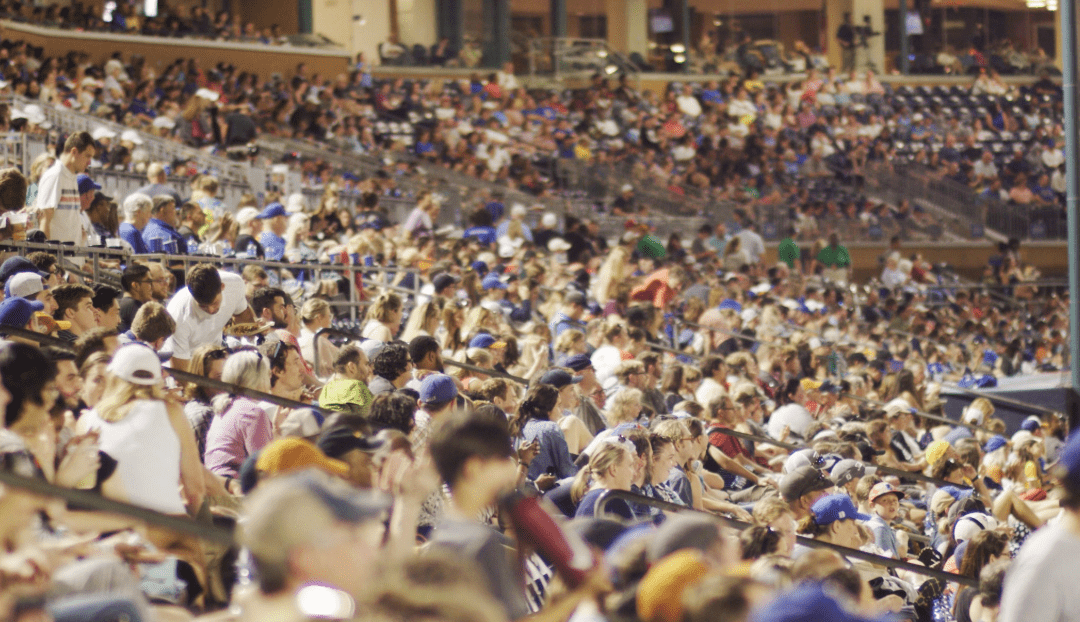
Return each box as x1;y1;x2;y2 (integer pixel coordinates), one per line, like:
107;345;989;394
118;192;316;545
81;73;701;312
998;524;1080;622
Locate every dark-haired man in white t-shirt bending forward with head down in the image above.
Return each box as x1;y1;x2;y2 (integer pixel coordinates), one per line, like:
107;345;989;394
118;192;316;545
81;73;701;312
165;263;255;371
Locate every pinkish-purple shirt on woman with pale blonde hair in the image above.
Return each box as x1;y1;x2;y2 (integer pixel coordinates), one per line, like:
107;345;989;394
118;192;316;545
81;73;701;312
203;396;272;477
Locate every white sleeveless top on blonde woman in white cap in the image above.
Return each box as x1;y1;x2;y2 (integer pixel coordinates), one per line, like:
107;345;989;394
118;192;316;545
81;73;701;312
83;400;187;515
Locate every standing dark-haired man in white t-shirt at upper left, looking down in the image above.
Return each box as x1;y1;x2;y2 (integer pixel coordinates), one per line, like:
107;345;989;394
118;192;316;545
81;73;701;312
35;132;96;244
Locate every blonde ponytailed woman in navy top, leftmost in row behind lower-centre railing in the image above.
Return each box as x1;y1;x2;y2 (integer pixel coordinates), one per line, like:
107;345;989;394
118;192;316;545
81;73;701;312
570;438;637;520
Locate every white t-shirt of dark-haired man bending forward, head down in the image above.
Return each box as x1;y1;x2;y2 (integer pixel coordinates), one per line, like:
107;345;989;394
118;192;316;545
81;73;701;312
164;270;247;361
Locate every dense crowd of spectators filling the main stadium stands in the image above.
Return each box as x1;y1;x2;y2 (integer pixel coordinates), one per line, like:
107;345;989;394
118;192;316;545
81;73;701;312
0;21;1080;622
